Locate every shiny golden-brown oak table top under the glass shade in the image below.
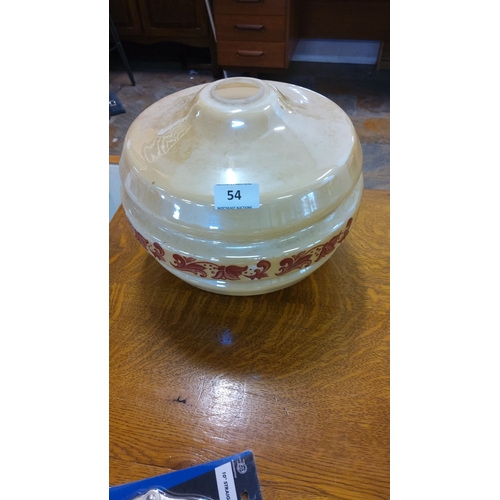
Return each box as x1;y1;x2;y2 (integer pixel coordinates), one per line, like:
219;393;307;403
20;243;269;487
109;190;389;500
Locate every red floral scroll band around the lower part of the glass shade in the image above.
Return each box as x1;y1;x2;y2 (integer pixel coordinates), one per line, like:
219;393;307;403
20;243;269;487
132;218;352;281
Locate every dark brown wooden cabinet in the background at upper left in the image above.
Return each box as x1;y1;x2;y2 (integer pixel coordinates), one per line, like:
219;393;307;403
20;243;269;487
109;0;221;78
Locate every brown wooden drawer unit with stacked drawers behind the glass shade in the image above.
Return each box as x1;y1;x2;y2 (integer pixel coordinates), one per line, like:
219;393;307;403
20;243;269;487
213;0;297;71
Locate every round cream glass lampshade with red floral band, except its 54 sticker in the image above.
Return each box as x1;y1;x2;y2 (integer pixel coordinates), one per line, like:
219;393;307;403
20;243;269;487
120;78;363;295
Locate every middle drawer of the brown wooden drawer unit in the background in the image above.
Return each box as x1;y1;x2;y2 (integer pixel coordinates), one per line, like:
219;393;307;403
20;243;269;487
215;15;286;42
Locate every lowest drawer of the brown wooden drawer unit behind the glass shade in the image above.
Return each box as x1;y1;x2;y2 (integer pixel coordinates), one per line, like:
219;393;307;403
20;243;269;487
217;41;286;68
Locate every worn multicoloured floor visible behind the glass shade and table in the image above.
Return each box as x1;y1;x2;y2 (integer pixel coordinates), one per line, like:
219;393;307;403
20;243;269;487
109;50;390;217
